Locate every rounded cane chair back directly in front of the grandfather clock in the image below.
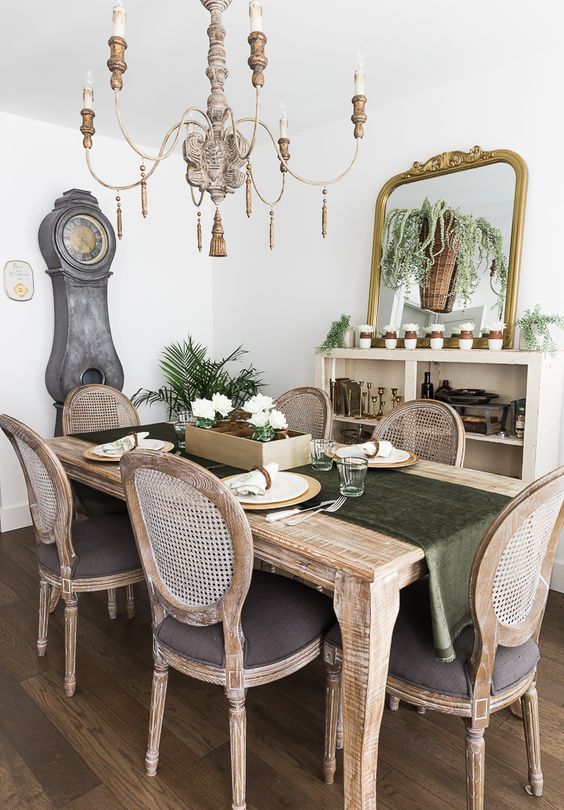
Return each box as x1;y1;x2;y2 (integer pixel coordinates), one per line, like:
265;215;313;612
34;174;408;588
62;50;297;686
62;385;140;436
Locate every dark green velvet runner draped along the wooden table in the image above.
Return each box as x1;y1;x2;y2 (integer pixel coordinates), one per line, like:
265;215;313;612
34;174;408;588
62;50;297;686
70;424;510;661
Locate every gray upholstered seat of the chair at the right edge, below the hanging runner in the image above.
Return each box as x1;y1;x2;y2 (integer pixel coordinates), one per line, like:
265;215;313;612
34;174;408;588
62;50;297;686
327;580;539;698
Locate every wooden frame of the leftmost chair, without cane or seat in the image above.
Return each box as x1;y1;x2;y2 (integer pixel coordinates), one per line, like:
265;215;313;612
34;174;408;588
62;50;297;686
0;414;144;697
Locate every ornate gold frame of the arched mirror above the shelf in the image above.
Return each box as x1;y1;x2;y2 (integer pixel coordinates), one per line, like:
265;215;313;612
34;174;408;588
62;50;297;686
366;146;528;349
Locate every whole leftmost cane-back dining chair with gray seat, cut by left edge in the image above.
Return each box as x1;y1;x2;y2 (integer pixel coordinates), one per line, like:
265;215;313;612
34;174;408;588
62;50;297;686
0;415;143;697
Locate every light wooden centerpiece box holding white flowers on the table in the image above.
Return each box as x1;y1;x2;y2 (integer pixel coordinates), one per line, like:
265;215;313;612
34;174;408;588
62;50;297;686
186;419;311;470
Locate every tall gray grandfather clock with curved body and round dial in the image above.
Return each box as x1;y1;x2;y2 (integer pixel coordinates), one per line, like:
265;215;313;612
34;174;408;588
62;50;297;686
39;188;123;436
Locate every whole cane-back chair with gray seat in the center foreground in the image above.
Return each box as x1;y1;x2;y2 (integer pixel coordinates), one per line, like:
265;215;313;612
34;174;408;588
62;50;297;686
120;450;334;810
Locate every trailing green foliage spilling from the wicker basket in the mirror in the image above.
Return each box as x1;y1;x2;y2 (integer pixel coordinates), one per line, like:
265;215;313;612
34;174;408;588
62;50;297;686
381;197;507;315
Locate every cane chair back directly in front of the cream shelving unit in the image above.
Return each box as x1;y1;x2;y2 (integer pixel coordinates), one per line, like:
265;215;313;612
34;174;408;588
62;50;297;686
372;399;466;467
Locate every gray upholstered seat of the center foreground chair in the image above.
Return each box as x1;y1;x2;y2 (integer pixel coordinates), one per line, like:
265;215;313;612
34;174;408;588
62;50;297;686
156;571;335;669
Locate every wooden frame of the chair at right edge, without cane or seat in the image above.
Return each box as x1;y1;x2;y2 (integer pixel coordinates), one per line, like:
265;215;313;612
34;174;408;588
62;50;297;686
324;466;564;810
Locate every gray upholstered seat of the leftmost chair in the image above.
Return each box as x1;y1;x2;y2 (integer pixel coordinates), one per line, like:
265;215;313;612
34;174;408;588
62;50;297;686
37;514;141;579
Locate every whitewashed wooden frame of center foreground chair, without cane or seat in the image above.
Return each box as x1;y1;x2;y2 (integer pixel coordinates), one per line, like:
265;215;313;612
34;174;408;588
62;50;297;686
120;450;323;810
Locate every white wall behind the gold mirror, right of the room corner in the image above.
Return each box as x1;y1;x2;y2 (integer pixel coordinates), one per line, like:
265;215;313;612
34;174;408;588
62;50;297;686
214;56;564;590
